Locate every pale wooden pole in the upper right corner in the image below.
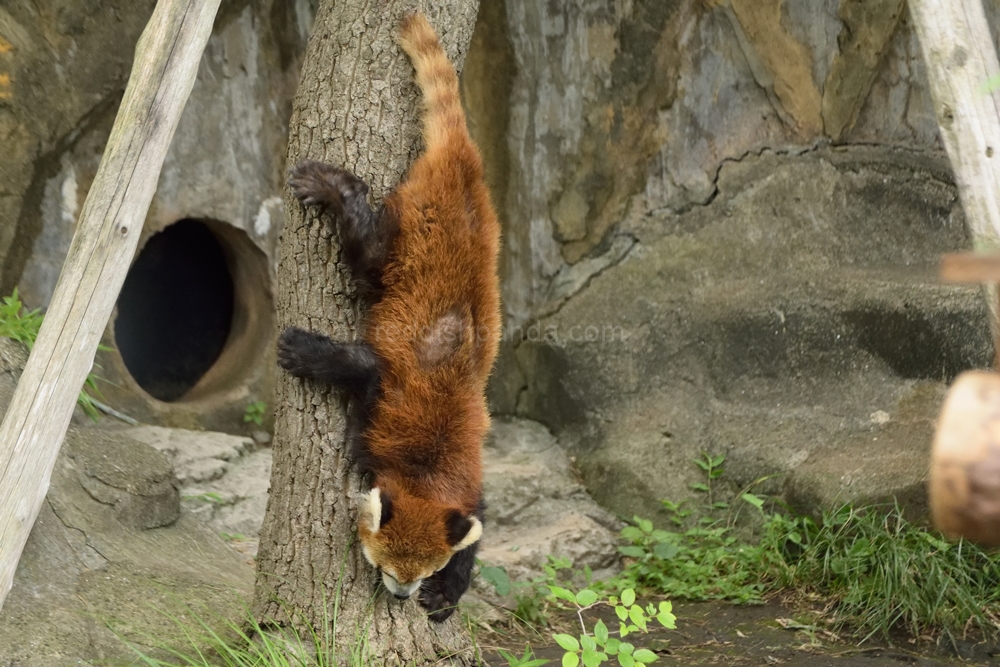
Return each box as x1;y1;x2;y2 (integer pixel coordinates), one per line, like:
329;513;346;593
909;0;1000;342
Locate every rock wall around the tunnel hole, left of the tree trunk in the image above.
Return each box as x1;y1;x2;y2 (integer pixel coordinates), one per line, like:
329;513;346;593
0;0;315;431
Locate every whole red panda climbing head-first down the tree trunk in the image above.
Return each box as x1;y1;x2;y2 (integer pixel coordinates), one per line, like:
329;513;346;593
278;15;500;622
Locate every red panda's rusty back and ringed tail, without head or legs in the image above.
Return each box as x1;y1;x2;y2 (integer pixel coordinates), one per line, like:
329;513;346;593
366;15;500;514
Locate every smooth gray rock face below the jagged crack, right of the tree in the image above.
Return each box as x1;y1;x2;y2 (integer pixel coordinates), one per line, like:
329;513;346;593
498;148;992;516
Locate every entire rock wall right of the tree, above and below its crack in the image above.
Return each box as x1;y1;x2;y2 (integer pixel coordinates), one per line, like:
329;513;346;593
466;0;998;516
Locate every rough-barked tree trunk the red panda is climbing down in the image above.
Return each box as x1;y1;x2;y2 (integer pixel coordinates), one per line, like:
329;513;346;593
253;0;479;665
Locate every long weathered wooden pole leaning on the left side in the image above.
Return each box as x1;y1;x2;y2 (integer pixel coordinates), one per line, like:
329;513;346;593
0;0;220;607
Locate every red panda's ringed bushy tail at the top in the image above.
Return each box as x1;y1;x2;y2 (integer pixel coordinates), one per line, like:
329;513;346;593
399;14;466;150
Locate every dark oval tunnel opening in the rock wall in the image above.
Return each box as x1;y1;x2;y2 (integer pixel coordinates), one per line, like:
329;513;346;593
115;219;234;401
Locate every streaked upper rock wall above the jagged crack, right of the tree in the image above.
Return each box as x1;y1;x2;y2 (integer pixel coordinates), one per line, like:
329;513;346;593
476;0;960;323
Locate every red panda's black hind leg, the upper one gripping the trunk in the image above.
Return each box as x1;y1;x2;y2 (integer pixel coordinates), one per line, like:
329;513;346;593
288;160;398;293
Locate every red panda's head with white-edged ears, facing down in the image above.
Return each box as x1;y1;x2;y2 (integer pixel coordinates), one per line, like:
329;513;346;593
358;487;483;600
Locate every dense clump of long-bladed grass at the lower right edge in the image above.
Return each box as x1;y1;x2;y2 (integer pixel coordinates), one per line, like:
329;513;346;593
770;505;1000;637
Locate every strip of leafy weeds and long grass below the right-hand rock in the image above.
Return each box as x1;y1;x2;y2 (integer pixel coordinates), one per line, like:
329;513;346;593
610;494;1000;638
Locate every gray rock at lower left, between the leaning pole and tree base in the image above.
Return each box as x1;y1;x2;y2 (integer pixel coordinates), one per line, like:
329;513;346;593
0;428;254;667
